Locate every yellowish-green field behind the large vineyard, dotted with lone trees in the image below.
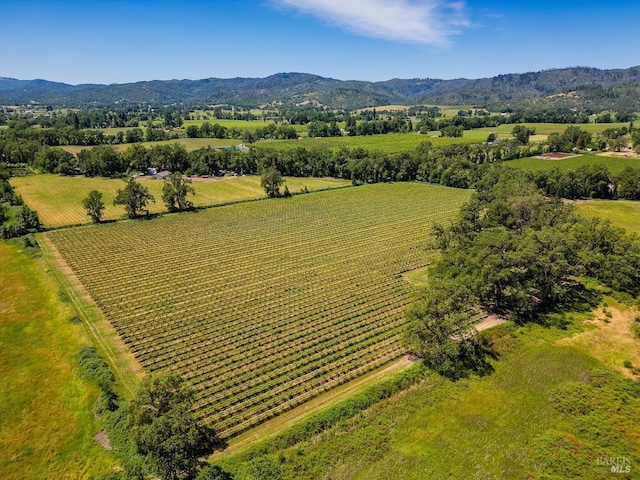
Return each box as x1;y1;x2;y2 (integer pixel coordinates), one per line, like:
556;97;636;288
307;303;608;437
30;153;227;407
11;174;351;227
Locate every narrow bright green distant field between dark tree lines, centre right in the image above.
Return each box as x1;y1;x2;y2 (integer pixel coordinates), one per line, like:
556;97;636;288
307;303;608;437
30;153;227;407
256;132;476;153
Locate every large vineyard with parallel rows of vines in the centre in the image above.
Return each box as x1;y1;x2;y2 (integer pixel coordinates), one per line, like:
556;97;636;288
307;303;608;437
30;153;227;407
47;183;469;437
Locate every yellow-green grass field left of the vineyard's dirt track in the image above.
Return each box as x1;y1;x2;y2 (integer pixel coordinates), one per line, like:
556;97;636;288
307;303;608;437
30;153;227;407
0;242;116;480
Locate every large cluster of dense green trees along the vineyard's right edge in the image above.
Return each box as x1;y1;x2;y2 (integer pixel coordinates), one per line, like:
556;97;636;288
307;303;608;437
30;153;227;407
408;161;640;360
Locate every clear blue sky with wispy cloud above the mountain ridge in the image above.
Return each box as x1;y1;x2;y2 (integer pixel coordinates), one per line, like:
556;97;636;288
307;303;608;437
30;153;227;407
0;0;640;84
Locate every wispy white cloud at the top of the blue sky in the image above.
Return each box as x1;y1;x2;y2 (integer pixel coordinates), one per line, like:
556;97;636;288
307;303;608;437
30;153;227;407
272;0;469;46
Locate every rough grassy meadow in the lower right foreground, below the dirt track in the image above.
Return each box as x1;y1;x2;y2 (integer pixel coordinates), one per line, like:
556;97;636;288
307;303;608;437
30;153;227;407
221;304;640;480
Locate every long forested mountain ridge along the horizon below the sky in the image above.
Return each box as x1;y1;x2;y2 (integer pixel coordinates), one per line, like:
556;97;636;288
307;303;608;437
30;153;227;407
0;66;640;109
